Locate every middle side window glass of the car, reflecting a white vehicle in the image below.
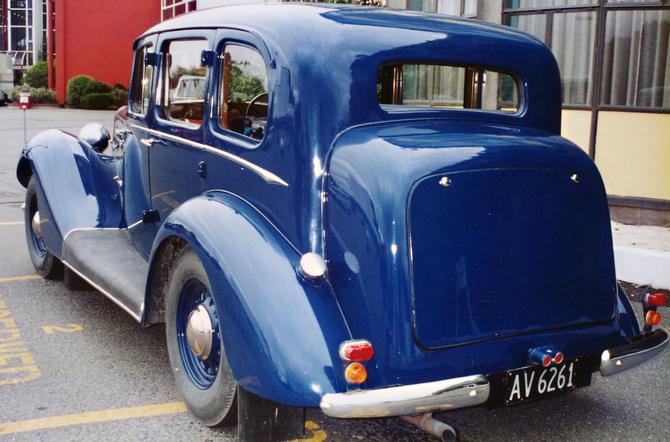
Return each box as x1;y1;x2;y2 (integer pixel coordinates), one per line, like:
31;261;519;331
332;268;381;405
163;40;209;127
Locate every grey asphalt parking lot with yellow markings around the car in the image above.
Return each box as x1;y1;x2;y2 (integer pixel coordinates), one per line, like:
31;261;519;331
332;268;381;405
0;108;670;442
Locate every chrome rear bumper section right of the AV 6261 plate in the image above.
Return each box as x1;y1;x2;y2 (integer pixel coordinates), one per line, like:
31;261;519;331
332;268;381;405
600;329;670;376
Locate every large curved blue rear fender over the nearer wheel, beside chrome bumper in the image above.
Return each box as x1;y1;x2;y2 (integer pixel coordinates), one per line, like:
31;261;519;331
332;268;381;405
148;192;351;406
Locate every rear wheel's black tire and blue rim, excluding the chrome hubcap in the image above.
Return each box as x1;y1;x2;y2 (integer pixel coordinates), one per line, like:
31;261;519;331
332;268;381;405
165;246;237;427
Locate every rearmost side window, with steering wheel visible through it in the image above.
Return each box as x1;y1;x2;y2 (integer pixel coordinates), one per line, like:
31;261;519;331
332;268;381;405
219;44;269;140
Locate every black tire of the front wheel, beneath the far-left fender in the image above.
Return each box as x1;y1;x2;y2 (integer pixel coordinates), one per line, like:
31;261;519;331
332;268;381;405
24;176;63;279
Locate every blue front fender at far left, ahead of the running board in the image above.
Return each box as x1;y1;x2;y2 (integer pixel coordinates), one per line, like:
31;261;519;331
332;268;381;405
16;129;122;258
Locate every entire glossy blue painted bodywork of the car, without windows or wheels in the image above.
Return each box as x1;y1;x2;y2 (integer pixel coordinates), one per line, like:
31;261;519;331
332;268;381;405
17;4;660;418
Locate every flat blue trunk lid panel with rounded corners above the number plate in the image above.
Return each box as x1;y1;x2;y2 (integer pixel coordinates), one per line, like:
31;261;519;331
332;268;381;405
409;168;614;349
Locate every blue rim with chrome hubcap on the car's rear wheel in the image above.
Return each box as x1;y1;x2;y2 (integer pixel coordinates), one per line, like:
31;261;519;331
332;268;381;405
177;278;221;390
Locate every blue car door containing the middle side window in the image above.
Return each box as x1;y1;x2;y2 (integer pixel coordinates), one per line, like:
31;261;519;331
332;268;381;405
150;30;215;226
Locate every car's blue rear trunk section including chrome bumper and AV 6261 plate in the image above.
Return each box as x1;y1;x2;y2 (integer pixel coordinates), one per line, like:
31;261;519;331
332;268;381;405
322;121;667;417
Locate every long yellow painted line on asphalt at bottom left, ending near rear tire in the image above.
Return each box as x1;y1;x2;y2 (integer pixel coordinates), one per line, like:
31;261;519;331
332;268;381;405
0;402;186;435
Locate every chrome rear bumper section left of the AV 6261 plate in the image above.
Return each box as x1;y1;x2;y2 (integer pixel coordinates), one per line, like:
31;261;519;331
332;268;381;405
321;375;490;418
